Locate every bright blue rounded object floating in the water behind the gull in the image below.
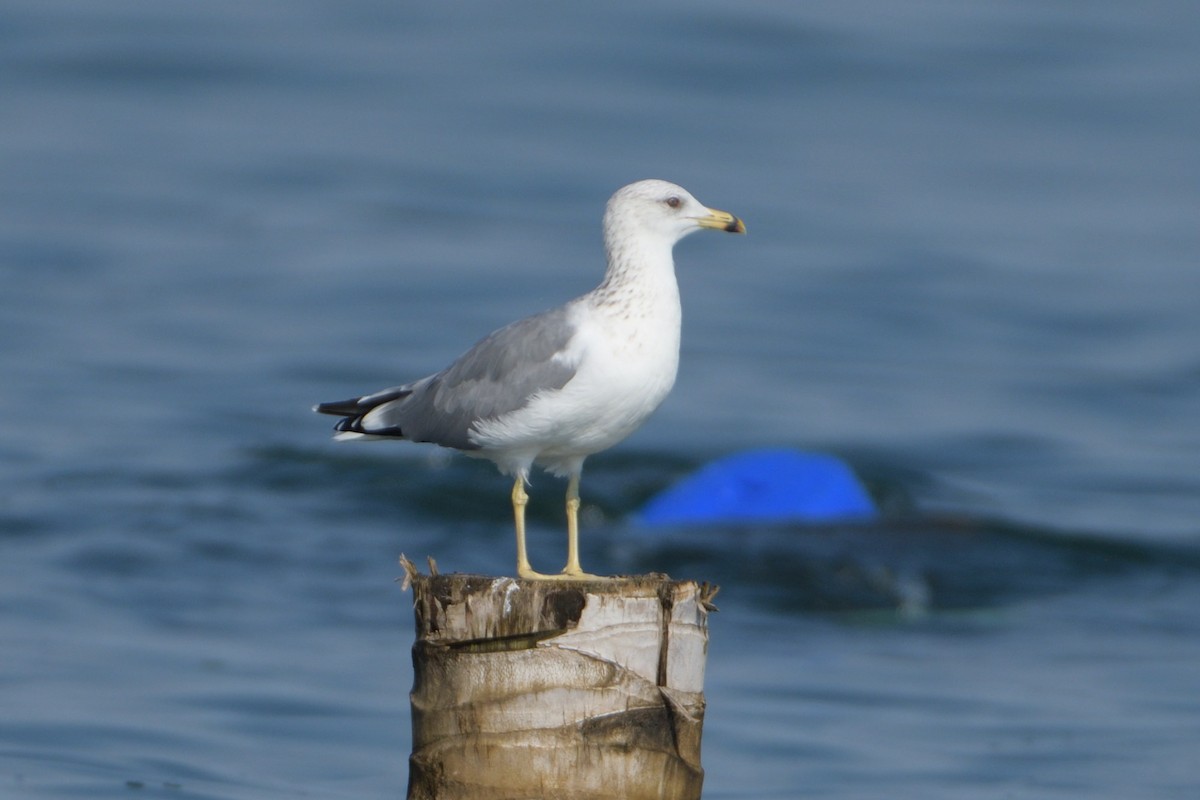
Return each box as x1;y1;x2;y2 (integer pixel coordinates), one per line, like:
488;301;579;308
637;450;878;525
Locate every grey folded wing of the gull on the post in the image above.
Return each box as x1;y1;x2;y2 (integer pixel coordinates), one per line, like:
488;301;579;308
362;307;575;450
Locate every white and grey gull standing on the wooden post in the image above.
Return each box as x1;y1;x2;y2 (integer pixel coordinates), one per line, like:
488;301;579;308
324;180;745;581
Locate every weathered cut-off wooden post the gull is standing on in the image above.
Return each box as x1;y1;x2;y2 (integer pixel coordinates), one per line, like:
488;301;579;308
402;559;716;800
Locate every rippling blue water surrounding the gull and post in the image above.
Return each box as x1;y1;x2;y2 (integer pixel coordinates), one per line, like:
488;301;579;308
0;0;1200;800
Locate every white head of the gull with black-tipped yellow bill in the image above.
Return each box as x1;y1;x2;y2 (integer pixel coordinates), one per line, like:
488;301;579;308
604;180;746;246
